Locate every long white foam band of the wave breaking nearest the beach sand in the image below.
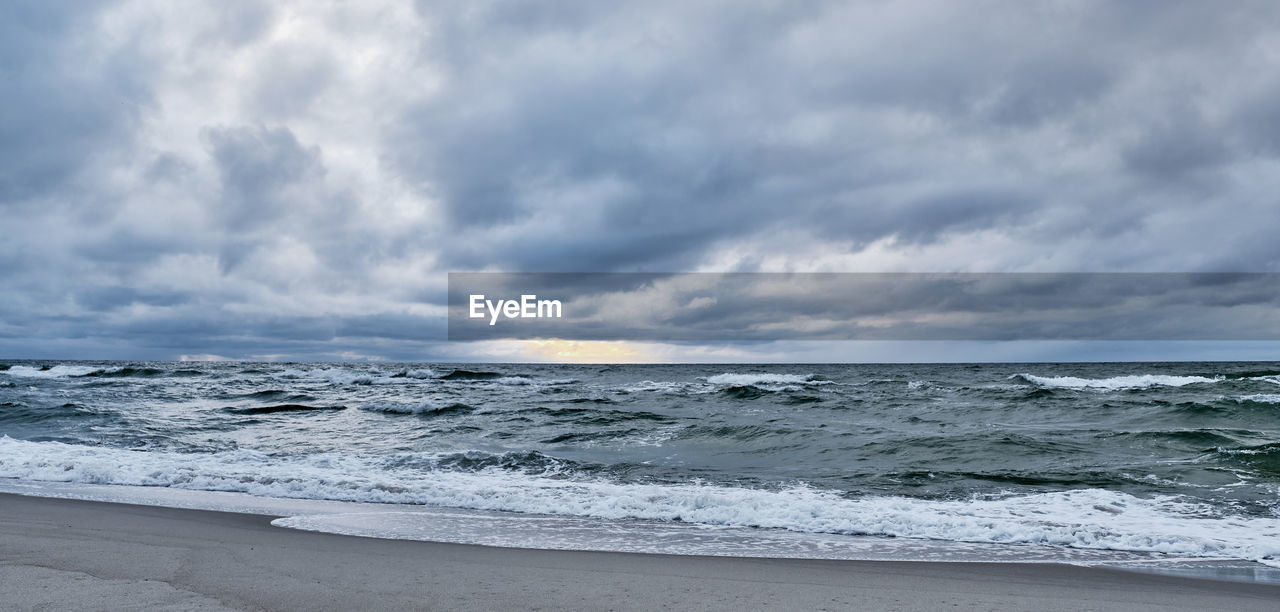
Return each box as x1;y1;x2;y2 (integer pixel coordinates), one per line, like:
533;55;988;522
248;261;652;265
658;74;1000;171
0;437;1280;562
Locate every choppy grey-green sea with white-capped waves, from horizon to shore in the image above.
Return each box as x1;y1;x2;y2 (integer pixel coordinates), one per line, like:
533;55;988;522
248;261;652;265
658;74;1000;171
0;361;1280;580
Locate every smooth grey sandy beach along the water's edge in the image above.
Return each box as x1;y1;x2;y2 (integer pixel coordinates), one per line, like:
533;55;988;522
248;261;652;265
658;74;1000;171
0;494;1280;611
